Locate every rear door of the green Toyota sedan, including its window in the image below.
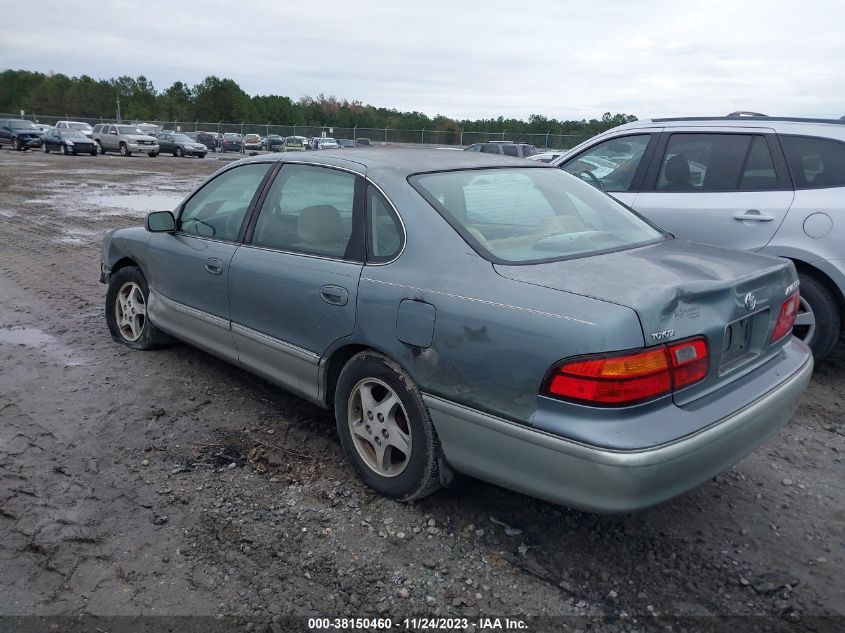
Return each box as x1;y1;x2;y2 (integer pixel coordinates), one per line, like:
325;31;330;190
229;164;364;399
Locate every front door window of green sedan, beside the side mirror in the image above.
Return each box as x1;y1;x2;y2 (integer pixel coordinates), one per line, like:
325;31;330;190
177;163;271;242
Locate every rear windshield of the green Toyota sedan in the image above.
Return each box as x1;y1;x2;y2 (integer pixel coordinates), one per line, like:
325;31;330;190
409;168;665;264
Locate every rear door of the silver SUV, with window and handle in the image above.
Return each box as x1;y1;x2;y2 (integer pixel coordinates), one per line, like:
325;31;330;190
632;128;794;251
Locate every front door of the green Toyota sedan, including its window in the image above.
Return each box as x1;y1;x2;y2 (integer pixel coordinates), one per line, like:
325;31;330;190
145;163;272;360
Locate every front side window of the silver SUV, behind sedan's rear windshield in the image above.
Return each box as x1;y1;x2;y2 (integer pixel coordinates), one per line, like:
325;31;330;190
561;134;651;191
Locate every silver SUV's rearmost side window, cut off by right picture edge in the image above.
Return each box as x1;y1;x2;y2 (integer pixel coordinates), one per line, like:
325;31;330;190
780;136;845;189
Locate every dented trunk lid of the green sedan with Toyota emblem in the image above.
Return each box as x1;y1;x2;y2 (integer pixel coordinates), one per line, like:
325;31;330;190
495;239;797;405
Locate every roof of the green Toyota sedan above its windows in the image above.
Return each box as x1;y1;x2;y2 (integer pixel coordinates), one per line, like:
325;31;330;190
245;147;549;176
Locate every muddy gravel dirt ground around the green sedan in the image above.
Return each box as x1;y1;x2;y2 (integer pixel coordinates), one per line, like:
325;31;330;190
0;150;845;630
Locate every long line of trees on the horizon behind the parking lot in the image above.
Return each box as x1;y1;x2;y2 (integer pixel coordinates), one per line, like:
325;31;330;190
0;69;636;136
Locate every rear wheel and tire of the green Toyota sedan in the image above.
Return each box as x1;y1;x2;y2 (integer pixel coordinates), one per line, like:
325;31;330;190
335;351;441;501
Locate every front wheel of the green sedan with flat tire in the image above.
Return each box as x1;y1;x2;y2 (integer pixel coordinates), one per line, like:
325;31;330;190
106;266;172;350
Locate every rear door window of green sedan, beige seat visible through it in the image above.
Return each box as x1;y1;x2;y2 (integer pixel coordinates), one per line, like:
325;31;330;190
251;164;363;260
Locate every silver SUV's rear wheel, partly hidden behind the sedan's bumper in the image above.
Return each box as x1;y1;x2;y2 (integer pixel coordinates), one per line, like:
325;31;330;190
792;275;842;363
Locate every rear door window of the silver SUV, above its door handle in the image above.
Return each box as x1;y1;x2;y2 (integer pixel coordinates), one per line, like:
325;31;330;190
656;134;778;191
